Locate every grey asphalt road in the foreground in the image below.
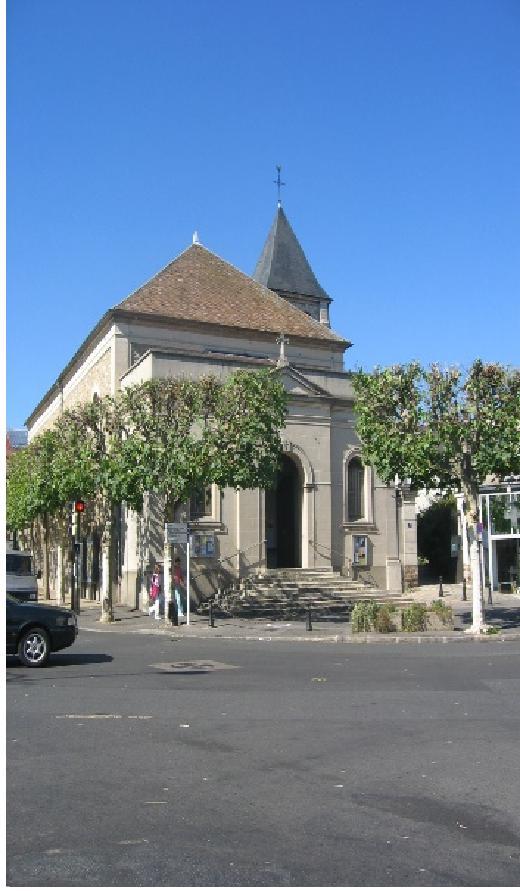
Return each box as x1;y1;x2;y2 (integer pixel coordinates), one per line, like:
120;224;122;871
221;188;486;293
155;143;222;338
7;632;520;886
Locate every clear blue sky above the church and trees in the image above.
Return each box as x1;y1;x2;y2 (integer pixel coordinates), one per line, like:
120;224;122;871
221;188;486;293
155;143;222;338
7;0;520;427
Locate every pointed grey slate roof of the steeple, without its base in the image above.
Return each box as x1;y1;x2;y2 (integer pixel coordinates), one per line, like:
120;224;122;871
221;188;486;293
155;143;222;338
253;207;330;300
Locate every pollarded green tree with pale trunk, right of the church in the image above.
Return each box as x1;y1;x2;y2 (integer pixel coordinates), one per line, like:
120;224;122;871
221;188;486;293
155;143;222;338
354;360;520;630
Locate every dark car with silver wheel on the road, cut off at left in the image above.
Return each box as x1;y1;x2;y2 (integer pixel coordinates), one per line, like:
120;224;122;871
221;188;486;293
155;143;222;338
5;594;78;668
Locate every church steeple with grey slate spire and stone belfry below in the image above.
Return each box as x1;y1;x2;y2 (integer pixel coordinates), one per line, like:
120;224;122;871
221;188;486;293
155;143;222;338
253;204;331;325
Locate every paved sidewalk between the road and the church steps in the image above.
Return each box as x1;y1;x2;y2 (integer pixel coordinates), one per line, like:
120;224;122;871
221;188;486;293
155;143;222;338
63;585;520;643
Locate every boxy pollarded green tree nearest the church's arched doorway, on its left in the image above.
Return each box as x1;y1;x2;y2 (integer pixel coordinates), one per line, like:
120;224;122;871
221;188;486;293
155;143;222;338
121;372;286;612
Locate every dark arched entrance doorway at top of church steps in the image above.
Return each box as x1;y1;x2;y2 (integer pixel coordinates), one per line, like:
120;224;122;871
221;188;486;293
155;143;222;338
265;455;303;569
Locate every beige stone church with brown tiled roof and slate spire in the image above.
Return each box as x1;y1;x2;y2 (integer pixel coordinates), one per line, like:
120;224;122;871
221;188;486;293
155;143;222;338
27;204;417;605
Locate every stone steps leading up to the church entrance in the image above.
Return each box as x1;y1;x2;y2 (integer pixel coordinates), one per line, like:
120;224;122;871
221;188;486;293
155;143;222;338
205;569;411;622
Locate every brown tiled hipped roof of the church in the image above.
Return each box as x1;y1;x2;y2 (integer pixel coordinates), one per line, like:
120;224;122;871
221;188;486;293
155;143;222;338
114;244;346;345
